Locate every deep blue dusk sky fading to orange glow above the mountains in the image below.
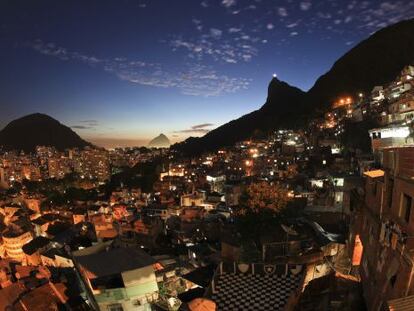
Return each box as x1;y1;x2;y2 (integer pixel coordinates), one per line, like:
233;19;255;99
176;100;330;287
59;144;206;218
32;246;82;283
0;0;414;147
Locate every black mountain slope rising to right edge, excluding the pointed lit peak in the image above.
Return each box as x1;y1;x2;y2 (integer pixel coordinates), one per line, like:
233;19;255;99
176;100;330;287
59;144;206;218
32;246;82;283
307;19;414;111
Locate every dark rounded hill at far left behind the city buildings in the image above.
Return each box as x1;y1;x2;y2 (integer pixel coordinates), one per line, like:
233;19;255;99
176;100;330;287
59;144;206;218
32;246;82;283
0;113;91;152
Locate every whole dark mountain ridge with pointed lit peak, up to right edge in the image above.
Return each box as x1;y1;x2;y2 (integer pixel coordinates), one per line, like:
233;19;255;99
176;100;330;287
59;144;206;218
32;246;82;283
173;19;414;155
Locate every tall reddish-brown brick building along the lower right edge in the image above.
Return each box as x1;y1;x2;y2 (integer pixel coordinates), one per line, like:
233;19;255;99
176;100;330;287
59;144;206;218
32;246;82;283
351;147;414;310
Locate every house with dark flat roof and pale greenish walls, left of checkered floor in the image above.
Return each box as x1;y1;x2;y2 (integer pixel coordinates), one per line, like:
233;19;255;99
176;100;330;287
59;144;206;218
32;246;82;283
74;246;158;311
